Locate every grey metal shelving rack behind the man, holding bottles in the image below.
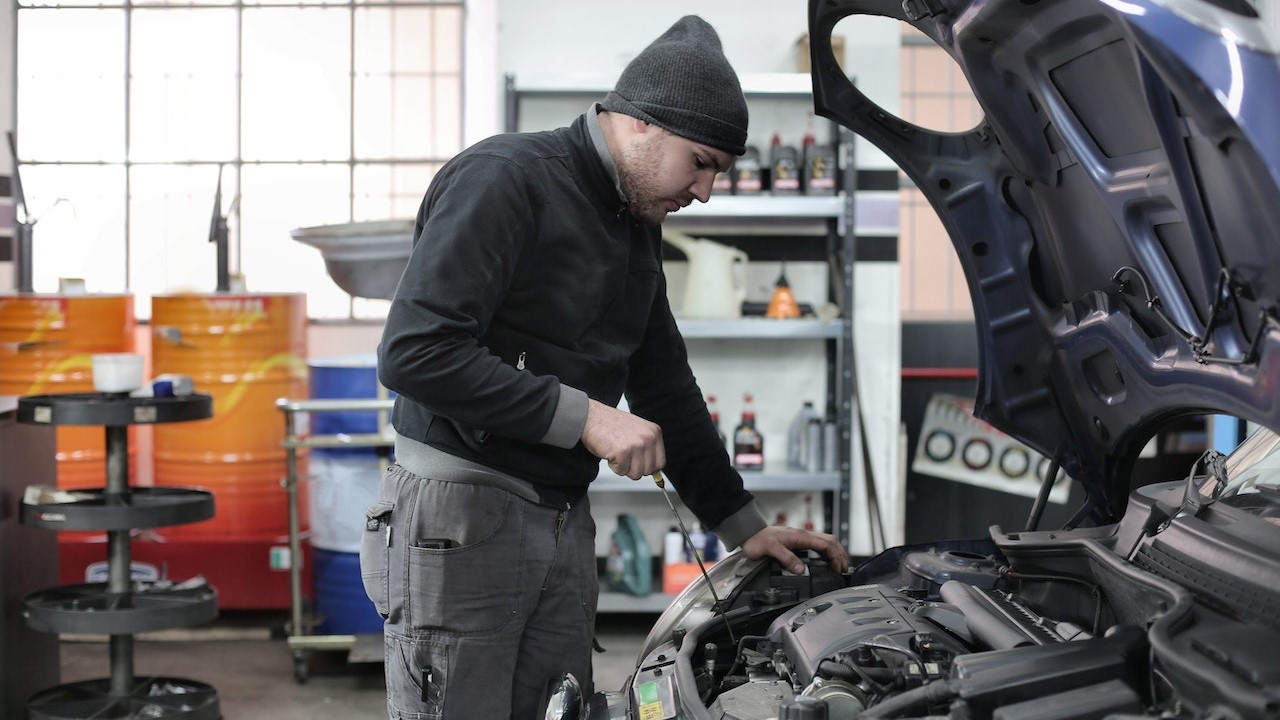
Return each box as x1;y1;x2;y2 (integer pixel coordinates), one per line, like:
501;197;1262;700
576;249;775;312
504;73;859;612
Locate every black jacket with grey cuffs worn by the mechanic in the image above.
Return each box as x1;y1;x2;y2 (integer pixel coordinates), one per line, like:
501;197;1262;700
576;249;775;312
378;115;751;528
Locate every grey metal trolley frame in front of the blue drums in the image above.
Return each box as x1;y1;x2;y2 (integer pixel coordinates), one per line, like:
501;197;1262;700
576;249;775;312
275;398;394;683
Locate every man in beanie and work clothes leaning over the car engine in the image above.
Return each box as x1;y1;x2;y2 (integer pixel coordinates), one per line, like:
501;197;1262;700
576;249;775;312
361;17;847;720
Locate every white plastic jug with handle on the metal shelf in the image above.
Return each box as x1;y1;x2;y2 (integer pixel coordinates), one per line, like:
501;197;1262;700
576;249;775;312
662;228;748;320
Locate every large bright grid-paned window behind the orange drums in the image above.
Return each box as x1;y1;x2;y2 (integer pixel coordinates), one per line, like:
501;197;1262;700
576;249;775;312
15;0;463;319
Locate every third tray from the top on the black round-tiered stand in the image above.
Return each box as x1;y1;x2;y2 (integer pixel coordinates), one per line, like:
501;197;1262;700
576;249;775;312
23;583;218;635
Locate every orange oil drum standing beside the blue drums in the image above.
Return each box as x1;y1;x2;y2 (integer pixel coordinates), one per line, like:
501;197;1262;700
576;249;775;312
151;293;307;539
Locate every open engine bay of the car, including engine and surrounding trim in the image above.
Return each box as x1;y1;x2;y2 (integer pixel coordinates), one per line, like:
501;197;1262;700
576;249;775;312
614;476;1280;720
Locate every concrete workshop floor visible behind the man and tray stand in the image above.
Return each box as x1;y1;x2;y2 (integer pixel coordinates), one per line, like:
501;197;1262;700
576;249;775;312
60;612;657;720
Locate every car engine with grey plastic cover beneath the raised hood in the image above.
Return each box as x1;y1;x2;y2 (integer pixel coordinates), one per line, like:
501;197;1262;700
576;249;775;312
703;551;1147;720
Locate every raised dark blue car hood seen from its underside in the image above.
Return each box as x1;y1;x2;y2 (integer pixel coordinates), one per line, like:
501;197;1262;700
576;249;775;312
809;0;1280;521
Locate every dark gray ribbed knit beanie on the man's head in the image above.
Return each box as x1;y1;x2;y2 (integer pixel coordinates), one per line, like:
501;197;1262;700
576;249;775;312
600;15;746;155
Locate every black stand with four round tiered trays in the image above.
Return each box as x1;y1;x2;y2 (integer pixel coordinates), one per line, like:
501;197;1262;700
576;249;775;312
18;392;221;720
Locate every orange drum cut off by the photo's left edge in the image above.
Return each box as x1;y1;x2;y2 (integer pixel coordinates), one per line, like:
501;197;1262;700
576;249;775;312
0;293;137;488
